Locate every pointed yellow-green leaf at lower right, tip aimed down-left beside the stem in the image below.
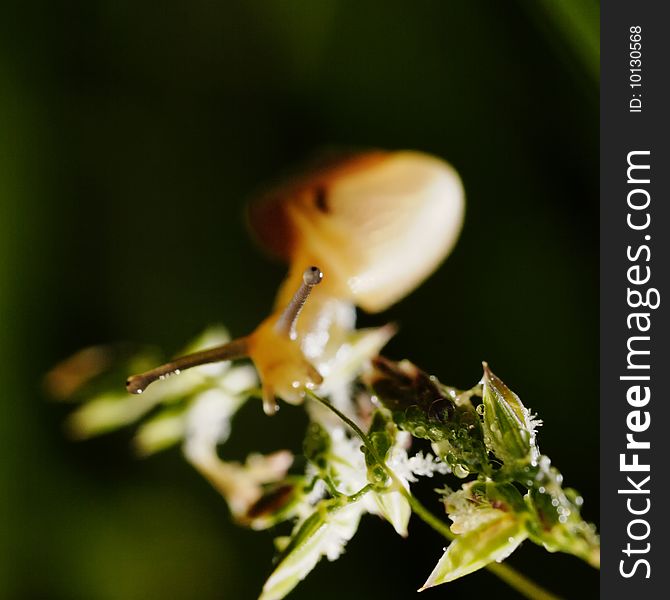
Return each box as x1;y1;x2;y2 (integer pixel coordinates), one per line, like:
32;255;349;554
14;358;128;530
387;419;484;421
419;511;527;591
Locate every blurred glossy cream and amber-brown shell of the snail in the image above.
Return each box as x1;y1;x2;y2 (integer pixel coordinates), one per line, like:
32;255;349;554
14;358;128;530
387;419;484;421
249;151;465;312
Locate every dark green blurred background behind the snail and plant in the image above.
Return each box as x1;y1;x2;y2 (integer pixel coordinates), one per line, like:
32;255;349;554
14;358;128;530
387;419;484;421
0;0;599;600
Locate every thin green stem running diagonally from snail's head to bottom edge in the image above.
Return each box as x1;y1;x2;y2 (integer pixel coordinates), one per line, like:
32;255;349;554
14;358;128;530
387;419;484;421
306;390;560;600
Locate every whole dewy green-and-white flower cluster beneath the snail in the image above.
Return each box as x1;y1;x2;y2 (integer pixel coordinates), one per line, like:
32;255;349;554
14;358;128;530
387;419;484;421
47;327;599;600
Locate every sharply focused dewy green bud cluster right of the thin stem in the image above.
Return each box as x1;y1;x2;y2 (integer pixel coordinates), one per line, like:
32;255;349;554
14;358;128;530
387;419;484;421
368;357;600;589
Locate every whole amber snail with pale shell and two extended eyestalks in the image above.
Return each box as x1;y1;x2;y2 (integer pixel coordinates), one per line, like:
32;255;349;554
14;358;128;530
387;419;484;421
126;151;465;415
